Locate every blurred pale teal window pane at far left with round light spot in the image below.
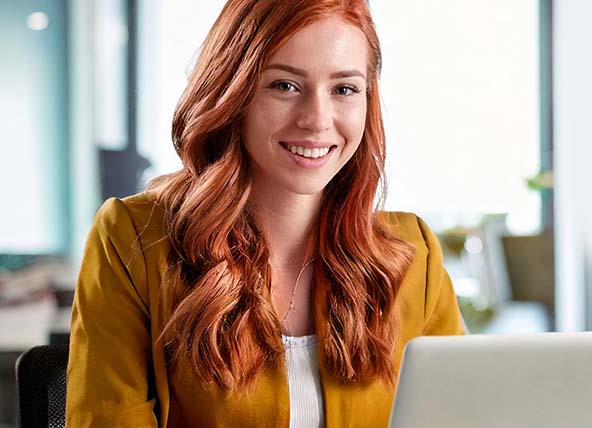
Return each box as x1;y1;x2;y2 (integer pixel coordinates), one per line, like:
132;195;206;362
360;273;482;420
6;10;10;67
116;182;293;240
0;1;69;254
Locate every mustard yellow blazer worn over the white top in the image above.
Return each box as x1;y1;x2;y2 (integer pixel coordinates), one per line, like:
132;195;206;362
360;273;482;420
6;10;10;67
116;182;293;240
66;193;464;428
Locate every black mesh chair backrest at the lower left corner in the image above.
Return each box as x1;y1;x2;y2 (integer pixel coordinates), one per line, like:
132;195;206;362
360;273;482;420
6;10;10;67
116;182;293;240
16;344;68;428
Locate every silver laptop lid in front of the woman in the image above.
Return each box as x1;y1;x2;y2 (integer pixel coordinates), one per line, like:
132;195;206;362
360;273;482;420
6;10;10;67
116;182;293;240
390;332;592;428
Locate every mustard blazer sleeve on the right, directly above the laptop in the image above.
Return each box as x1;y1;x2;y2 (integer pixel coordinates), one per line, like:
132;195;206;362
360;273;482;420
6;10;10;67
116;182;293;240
418;218;466;336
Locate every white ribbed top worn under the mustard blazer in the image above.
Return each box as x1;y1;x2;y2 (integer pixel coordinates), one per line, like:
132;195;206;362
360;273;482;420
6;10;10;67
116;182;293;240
282;334;325;428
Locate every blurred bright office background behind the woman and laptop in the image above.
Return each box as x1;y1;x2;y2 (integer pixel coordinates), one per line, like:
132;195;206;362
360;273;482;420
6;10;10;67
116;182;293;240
0;0;592;427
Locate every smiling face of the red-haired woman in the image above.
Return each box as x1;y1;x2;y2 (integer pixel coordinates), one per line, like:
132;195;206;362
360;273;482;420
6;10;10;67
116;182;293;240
243;18;368;194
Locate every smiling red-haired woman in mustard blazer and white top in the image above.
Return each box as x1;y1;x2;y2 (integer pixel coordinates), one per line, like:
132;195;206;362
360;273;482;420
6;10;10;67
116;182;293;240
67;0;463;428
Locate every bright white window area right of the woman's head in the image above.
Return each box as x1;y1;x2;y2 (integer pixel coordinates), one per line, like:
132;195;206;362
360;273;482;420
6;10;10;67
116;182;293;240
370;0;541;232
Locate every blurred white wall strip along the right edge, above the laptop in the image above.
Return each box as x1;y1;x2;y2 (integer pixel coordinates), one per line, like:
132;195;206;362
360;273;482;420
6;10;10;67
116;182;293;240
553;0;592;331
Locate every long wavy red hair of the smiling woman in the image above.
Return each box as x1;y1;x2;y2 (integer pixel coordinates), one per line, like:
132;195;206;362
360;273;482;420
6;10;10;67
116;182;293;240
149;0;414;391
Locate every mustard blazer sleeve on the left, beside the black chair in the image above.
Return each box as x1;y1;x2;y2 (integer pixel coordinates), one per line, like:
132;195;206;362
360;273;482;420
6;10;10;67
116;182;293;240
66;198;157;428
